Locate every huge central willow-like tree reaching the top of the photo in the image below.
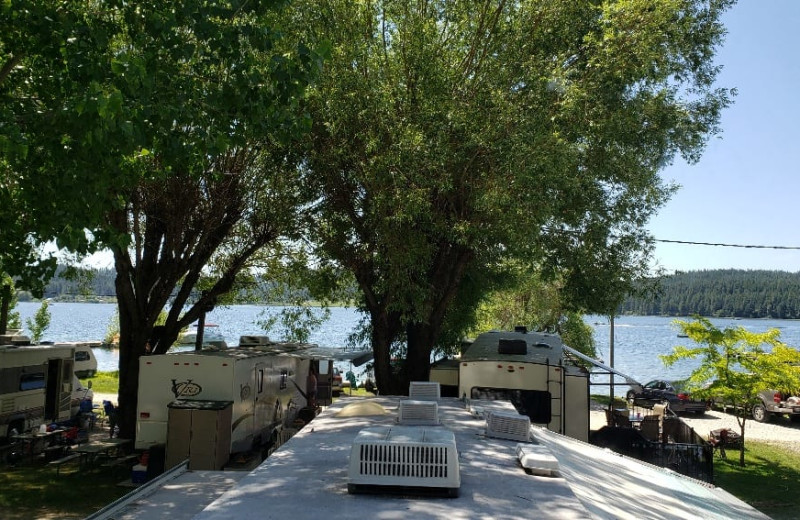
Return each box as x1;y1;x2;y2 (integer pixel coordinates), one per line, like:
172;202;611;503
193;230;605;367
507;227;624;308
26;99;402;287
293;0;732;393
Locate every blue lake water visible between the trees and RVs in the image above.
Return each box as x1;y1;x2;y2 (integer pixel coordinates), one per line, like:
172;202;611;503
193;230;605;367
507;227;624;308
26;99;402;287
17;302;800;395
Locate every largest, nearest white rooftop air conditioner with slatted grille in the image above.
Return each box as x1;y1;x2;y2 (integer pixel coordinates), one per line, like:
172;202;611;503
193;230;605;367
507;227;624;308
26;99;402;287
347;426;461;497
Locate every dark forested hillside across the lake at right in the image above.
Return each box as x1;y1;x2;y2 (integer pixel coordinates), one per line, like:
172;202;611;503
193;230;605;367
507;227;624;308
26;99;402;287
622;269;800;319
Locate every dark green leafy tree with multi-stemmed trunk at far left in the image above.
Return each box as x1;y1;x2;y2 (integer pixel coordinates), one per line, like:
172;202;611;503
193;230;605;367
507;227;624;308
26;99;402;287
0;0;320;437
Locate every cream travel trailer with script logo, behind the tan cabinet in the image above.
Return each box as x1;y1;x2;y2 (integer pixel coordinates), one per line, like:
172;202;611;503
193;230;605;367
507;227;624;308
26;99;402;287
136;343;309;458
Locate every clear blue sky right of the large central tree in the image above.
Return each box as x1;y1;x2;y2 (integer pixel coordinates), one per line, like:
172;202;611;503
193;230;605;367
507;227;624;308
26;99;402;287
649;0;800;272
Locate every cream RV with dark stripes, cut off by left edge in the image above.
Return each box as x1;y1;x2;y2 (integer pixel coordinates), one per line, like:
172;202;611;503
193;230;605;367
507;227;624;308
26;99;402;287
0;345;75;439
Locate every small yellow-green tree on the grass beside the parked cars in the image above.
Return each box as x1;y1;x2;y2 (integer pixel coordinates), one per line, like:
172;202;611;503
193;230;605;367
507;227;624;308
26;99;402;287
661;317;800;466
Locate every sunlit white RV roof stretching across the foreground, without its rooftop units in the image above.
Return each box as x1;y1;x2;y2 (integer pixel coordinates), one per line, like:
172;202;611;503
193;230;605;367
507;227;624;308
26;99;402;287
195;397;768;520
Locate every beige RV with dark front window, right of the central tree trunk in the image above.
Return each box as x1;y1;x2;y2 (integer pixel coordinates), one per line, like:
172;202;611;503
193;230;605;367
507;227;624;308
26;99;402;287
430;330;589;441
